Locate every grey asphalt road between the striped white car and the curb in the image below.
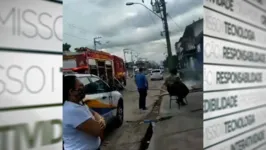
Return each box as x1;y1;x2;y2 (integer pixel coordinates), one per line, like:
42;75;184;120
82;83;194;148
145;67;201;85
101;76;163;150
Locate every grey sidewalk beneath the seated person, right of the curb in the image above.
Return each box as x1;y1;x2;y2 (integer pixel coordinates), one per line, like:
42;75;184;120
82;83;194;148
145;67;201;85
148;92;203;150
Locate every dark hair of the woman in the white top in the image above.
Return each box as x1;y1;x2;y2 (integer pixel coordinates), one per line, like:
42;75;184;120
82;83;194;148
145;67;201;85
63;76;76;103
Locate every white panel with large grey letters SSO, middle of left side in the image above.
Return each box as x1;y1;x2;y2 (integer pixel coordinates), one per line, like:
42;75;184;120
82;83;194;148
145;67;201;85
0;52;62;108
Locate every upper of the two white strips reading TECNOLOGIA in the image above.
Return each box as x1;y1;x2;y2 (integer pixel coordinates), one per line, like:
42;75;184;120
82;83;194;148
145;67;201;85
204;9;266;49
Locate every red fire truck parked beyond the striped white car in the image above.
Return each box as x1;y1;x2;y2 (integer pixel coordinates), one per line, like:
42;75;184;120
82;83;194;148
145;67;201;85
63;49;126;85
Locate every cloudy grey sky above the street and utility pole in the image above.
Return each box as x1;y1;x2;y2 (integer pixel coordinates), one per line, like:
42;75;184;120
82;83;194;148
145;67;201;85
63;0;203;62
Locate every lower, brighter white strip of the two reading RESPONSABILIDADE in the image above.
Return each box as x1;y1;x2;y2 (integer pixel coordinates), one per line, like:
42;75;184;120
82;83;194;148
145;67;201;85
204;65;266;92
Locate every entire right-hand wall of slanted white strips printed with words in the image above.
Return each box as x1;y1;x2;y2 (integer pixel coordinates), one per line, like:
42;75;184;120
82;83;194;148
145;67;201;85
203;0;266;150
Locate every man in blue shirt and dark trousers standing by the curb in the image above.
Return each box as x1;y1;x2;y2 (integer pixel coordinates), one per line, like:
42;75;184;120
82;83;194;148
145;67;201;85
135;68;149;110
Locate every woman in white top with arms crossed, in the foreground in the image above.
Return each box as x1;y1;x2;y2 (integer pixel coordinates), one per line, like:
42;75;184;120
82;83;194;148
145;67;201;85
63;76;105;150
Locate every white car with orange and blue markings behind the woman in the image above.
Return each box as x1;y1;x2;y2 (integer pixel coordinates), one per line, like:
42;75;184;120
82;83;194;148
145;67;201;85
66;74;124;127
